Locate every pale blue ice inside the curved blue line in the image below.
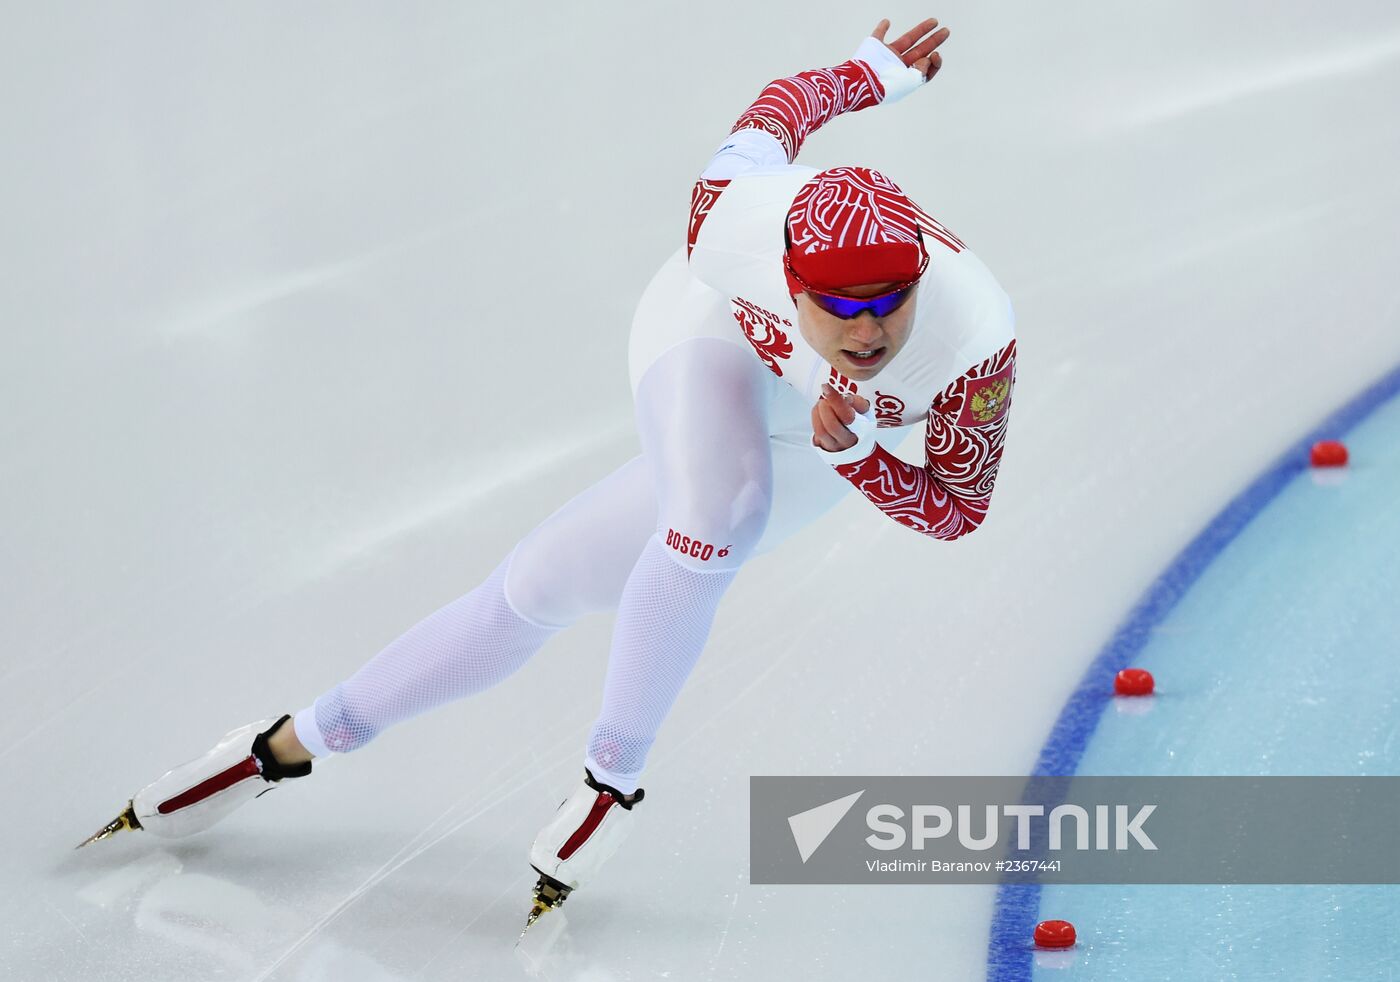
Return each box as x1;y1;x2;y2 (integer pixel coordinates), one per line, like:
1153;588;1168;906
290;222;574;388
1033;398;1400;982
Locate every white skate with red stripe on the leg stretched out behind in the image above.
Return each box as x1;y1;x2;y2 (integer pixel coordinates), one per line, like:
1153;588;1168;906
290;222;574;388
77;716;311;849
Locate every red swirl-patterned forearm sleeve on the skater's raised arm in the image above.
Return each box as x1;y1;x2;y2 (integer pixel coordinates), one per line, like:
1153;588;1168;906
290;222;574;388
729;59;885;164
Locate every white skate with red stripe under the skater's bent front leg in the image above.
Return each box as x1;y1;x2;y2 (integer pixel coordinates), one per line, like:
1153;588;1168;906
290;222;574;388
525;768;645;929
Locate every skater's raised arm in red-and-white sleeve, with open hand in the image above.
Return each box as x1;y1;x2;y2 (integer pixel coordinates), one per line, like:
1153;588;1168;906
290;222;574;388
687;18;948;252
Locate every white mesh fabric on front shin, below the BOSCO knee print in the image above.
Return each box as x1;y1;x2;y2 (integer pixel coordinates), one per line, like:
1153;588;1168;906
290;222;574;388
585;538;738;794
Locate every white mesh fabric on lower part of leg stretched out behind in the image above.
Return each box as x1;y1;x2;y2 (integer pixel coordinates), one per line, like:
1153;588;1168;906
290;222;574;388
310;558;559;754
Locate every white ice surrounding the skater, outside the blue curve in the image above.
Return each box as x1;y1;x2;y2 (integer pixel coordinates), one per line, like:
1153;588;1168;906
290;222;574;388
0;0;1400;982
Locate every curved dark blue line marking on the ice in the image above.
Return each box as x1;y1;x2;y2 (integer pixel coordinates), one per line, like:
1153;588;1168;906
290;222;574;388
987;355;1400;982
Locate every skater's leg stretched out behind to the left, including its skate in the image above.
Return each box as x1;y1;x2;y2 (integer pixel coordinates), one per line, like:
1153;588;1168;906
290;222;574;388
84;459;655;845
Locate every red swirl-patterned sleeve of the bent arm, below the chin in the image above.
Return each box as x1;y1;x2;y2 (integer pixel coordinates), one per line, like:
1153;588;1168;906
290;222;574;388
836;340;1016;539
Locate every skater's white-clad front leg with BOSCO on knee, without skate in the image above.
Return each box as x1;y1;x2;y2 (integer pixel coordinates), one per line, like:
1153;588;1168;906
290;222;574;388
585;338;774;794
